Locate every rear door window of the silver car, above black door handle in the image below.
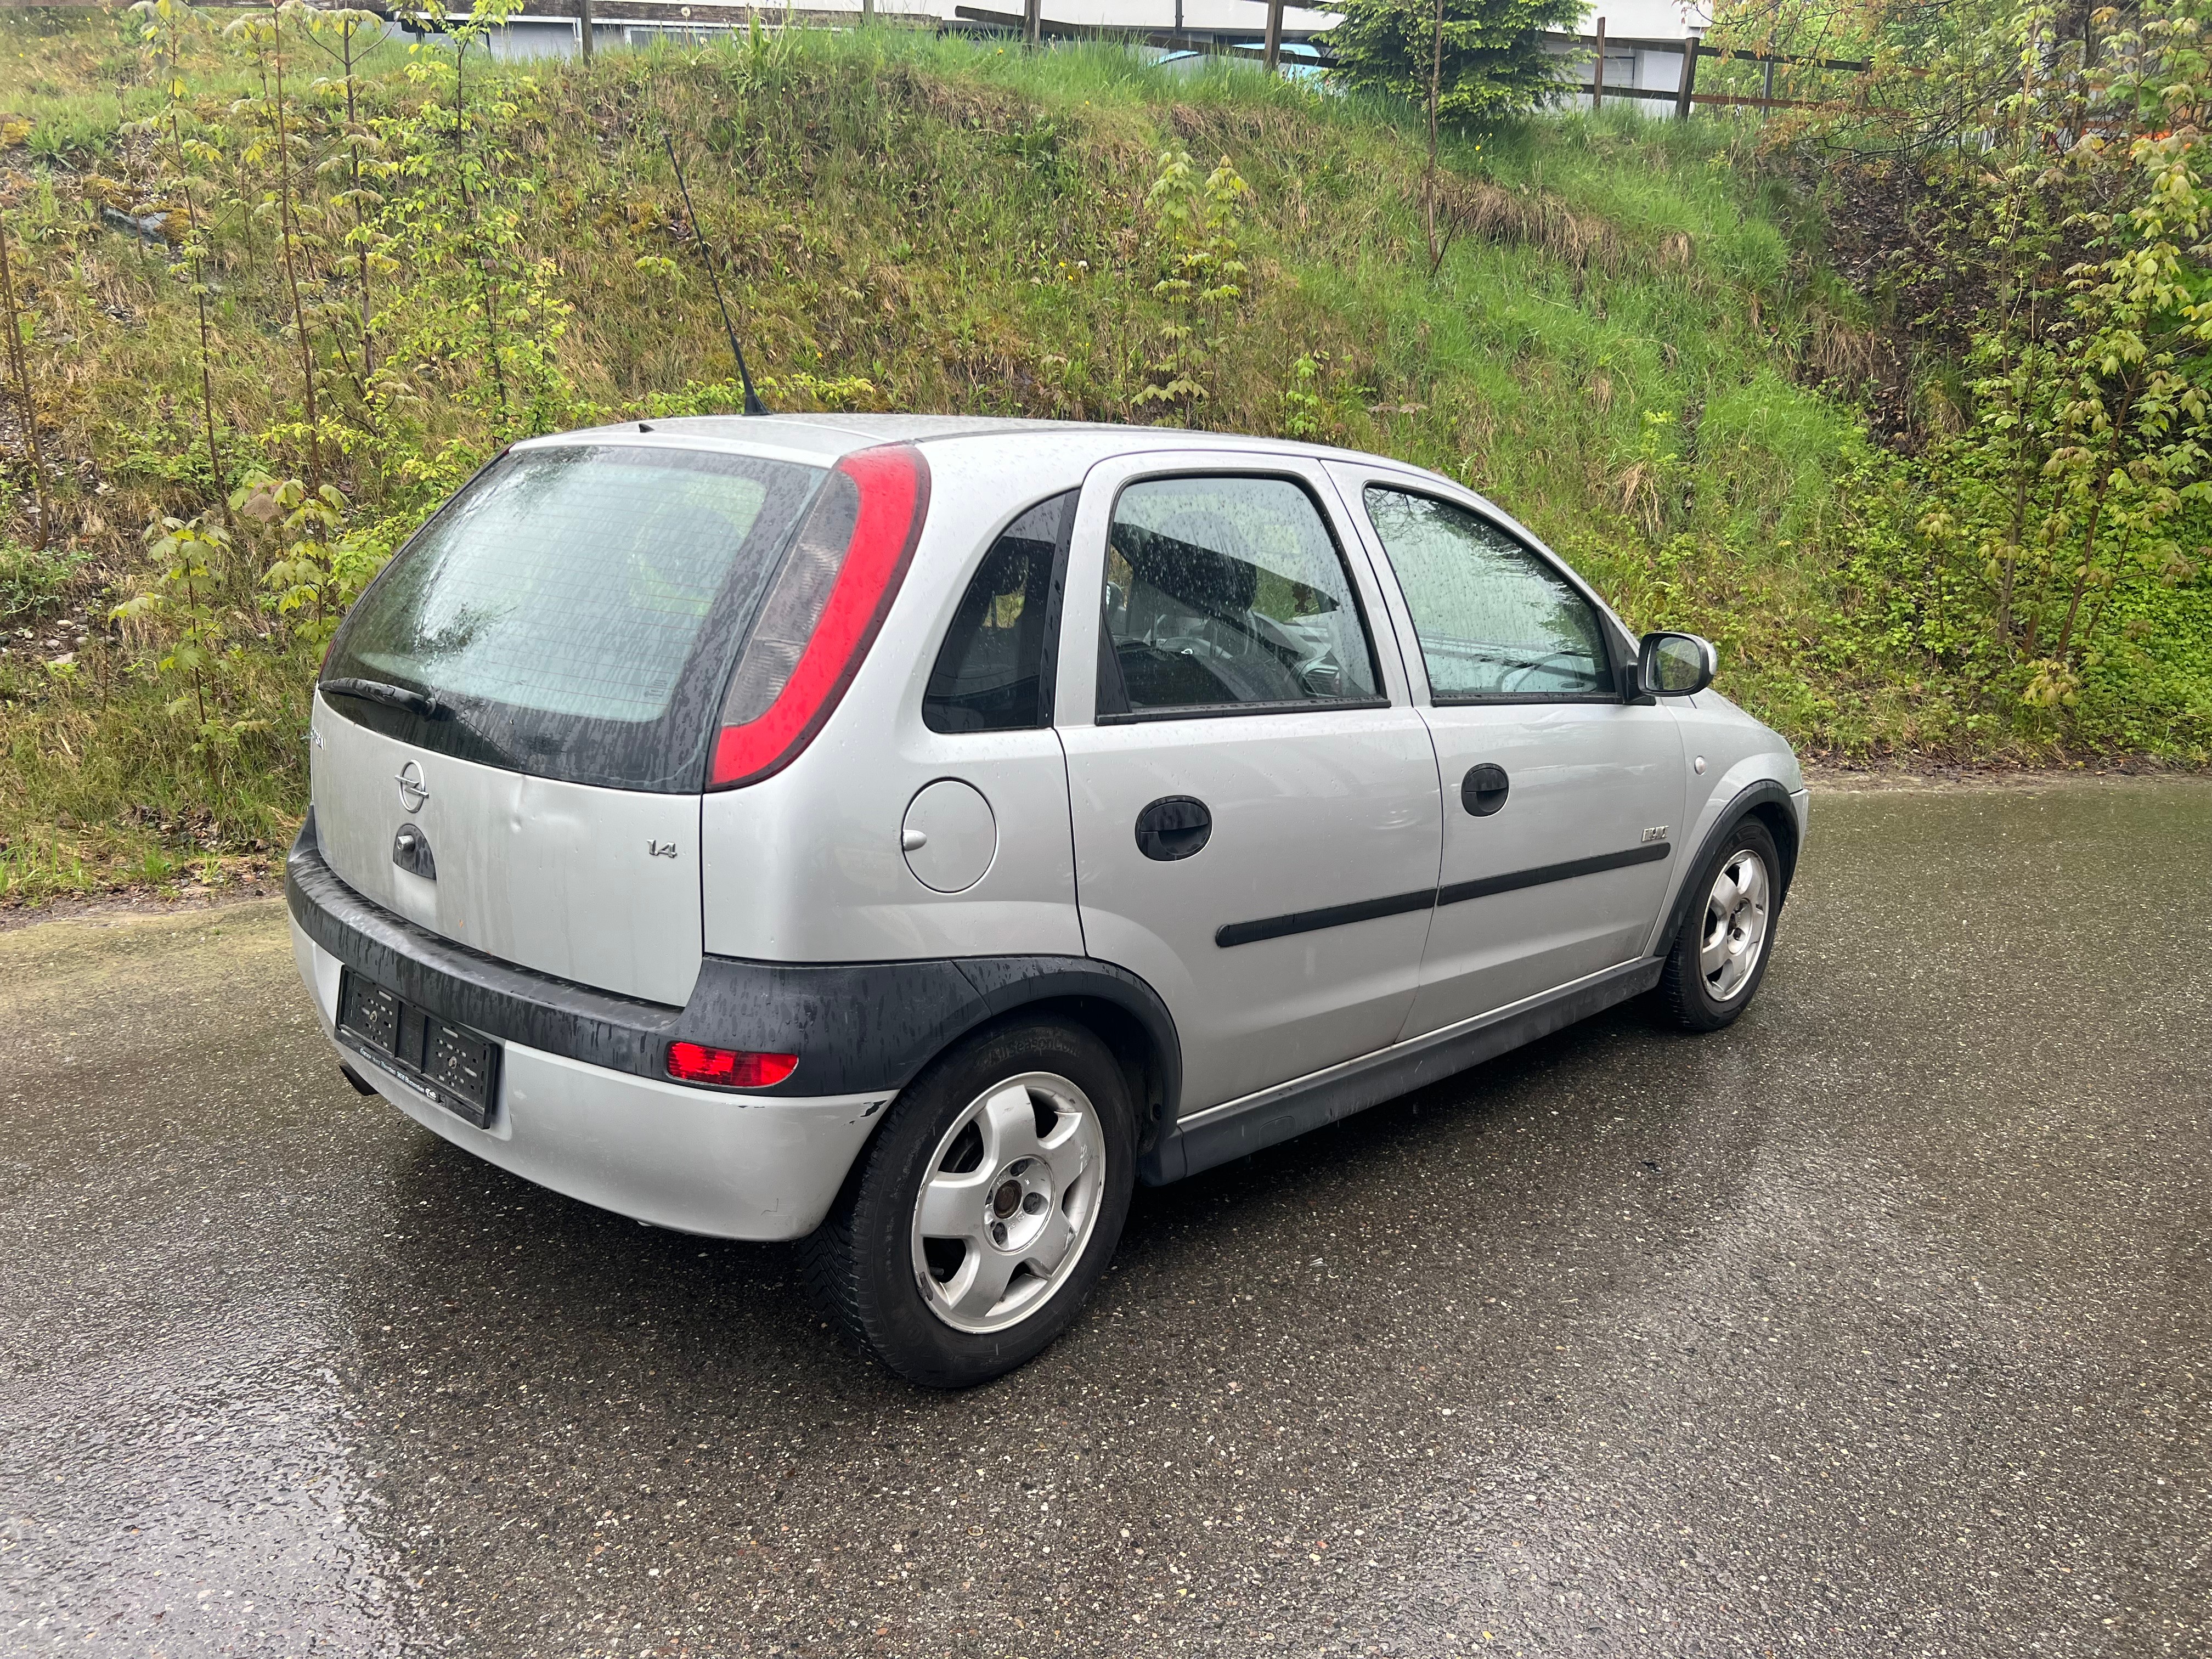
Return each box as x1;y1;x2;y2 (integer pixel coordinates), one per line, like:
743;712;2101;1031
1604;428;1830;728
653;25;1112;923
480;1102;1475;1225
1099;476;1380;719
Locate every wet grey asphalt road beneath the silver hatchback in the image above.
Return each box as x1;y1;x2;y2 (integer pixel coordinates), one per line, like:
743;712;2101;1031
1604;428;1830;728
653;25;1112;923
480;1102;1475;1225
0;781;2212;1659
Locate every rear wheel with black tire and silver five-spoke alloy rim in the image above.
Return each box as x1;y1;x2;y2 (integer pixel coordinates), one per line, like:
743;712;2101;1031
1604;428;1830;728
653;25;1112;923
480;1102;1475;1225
801;1020;1137;1389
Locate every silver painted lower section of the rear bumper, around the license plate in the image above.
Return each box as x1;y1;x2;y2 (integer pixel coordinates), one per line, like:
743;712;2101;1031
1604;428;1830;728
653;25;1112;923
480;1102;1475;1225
292;920;894;1239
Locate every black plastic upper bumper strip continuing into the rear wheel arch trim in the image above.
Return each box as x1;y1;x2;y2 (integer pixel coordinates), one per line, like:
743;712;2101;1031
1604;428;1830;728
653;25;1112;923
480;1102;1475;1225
285;810;1183;1119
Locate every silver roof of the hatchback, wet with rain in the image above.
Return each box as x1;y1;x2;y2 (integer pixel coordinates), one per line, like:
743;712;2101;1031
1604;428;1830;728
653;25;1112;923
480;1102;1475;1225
515;414;1462;489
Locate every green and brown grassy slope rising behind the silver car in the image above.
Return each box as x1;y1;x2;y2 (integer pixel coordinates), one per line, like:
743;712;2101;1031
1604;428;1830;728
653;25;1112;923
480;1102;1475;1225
0;18;2212;898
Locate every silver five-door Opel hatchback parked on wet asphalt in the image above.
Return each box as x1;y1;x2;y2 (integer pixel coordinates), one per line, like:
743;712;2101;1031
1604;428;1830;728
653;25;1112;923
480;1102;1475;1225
285;416;1807;1387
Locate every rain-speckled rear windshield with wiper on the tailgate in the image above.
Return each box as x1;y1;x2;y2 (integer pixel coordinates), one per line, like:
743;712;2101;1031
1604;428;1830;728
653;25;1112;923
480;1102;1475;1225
323;444;825;792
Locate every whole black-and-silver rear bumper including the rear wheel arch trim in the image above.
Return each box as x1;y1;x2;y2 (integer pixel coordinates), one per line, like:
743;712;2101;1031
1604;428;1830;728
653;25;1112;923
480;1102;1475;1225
285;810;1181;1239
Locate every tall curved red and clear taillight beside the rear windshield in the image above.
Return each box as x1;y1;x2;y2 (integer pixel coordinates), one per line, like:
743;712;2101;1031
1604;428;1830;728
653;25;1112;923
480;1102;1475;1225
708;444;929;789
